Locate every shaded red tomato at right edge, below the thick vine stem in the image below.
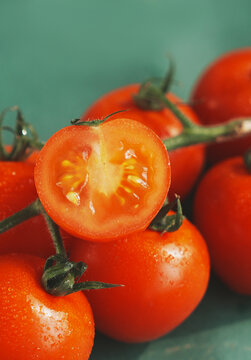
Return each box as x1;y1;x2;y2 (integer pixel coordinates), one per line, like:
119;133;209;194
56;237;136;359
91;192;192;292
194;157;251;295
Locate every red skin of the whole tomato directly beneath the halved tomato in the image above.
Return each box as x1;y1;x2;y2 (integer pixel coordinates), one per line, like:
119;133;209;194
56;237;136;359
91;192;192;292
71;220;209;343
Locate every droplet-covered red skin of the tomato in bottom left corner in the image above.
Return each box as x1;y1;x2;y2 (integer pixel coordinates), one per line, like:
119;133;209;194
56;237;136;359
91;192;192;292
0;254;94;360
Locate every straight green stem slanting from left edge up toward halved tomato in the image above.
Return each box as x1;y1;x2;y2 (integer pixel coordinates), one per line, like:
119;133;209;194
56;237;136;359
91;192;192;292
0;199;41;234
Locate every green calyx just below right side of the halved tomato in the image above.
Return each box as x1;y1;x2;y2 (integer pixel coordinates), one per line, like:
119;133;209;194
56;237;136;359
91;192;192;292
149;195;185;234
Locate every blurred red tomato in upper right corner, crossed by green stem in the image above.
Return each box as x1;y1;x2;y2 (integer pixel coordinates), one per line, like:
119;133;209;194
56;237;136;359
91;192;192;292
191;47;251;163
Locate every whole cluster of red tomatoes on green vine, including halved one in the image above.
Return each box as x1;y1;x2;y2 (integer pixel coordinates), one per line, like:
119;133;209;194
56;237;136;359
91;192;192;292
0;48;251;360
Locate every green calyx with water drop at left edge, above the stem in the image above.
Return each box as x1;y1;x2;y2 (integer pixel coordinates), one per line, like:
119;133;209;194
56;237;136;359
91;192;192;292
0;106;44;161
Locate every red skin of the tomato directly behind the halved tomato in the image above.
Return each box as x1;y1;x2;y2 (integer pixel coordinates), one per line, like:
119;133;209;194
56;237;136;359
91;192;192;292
81;84;205;199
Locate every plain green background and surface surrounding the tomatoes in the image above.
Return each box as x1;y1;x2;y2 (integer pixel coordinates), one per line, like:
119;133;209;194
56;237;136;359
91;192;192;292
0;0;251;360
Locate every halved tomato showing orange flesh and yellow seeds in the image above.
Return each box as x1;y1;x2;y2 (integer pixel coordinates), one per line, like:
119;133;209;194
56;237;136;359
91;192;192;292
35;119;170;241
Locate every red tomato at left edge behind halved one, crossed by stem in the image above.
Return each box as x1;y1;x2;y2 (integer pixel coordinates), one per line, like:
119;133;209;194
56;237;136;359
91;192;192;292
0;159;71;257
